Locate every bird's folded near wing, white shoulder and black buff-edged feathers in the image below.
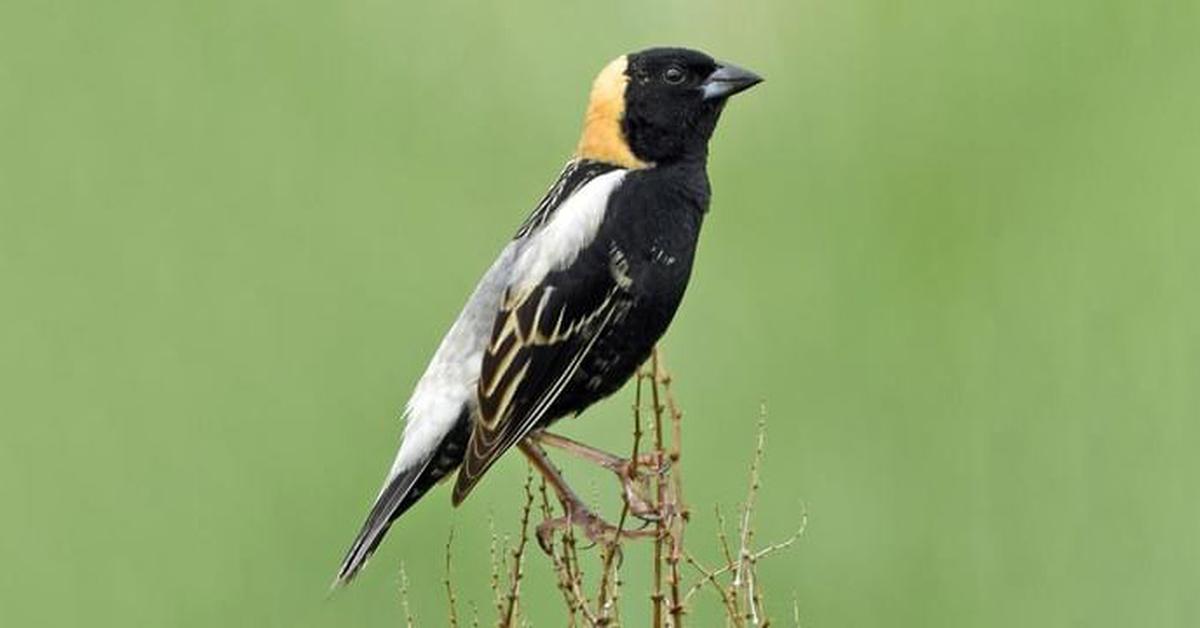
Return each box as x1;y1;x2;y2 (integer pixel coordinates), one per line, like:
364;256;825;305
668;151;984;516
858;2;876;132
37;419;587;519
452;161;628;504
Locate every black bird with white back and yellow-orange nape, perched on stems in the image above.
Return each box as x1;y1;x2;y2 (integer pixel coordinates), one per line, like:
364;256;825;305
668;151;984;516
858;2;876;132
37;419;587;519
334;47;763;587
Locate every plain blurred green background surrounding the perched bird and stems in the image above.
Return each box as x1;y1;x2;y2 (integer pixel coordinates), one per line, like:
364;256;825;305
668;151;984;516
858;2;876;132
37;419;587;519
0;0;1200;627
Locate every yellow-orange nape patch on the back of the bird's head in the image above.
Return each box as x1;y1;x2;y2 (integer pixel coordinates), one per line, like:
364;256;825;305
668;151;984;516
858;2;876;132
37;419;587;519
575;55;650;168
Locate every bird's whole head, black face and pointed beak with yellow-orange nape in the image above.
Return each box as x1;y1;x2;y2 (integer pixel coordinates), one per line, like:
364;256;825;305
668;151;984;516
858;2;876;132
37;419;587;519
578;48;762;167
